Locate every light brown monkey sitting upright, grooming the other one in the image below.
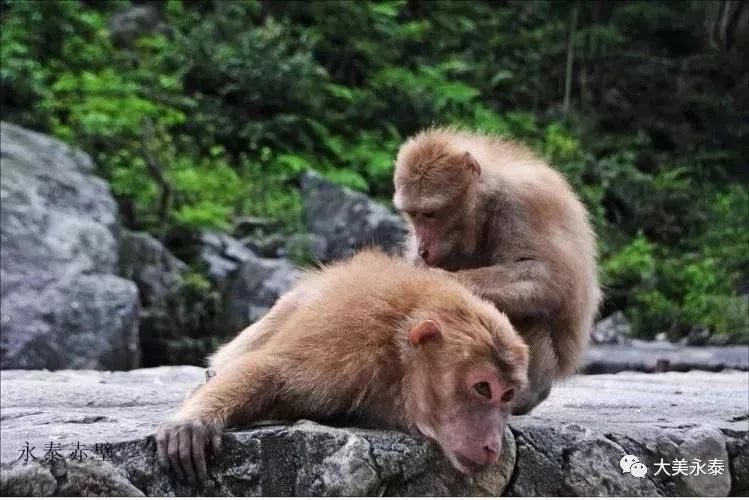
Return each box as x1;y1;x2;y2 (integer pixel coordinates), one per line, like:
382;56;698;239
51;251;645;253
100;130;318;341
393;127;601;414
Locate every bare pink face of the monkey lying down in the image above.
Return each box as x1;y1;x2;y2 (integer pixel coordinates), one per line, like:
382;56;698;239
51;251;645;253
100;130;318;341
418;369;515;474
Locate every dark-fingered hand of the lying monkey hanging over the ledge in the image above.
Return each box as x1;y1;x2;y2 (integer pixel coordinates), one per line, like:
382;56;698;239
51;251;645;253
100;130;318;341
156;416;224;486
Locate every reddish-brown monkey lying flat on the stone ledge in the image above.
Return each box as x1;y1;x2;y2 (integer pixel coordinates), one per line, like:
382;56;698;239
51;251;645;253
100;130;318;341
156;249;528;485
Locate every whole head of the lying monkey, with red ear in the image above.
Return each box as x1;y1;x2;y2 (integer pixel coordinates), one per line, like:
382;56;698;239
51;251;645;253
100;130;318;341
411;314;527;474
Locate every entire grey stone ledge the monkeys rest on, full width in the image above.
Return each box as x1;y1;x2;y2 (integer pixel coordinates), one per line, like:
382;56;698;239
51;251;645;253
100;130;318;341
0;367;749;496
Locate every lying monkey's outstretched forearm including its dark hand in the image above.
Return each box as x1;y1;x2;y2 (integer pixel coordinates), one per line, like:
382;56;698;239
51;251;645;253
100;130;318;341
156;352;278;485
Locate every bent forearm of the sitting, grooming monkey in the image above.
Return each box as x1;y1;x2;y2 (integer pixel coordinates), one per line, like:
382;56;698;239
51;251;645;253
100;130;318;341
453;260;561;318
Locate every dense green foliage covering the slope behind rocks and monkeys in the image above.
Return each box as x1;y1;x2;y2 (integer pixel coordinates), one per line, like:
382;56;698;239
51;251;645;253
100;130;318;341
0;0;749;349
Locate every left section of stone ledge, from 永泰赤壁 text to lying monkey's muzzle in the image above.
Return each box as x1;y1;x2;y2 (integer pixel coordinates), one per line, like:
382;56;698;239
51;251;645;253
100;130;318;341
0;367;515;496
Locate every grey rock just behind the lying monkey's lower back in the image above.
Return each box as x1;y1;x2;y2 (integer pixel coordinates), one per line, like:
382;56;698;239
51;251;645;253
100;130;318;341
221;255;300;333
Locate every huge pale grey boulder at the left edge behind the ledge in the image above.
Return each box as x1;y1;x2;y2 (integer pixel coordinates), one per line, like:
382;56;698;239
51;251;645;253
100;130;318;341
0;123;138;369
